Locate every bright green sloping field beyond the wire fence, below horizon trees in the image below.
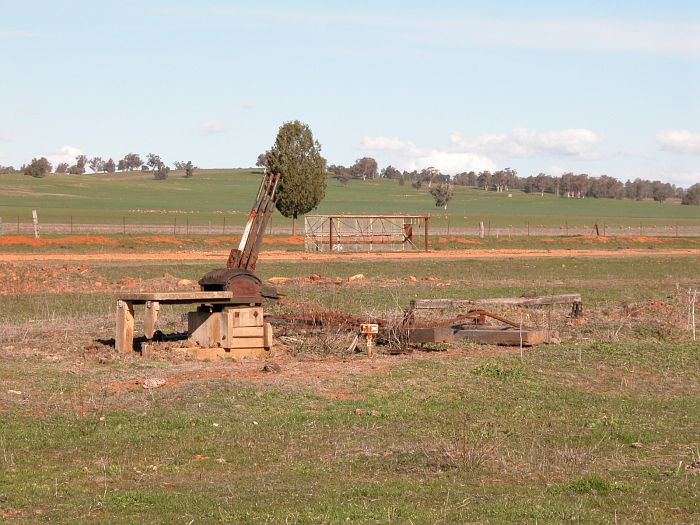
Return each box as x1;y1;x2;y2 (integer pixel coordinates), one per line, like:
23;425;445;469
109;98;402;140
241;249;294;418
5;170;700;235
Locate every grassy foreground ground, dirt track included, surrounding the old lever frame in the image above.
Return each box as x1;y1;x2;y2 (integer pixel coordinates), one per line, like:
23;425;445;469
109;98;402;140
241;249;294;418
0;245;700;524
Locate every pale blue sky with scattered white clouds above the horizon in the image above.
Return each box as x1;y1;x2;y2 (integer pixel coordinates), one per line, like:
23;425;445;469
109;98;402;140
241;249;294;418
0;0;700;187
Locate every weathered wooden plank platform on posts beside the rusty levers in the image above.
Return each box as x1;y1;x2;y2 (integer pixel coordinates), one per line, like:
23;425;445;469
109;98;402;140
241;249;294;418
114;290;259;352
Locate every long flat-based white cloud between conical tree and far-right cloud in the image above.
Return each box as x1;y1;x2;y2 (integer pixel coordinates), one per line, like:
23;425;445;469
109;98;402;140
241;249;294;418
450;128;602;158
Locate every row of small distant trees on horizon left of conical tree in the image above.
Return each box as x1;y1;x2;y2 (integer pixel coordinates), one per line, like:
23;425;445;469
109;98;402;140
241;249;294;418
10;153;197;180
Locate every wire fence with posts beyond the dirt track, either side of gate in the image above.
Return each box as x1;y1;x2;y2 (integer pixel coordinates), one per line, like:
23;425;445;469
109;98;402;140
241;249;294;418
0;218;700;238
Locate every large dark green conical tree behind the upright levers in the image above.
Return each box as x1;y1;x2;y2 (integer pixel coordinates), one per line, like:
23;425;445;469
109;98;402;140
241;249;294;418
267;120;326;235
